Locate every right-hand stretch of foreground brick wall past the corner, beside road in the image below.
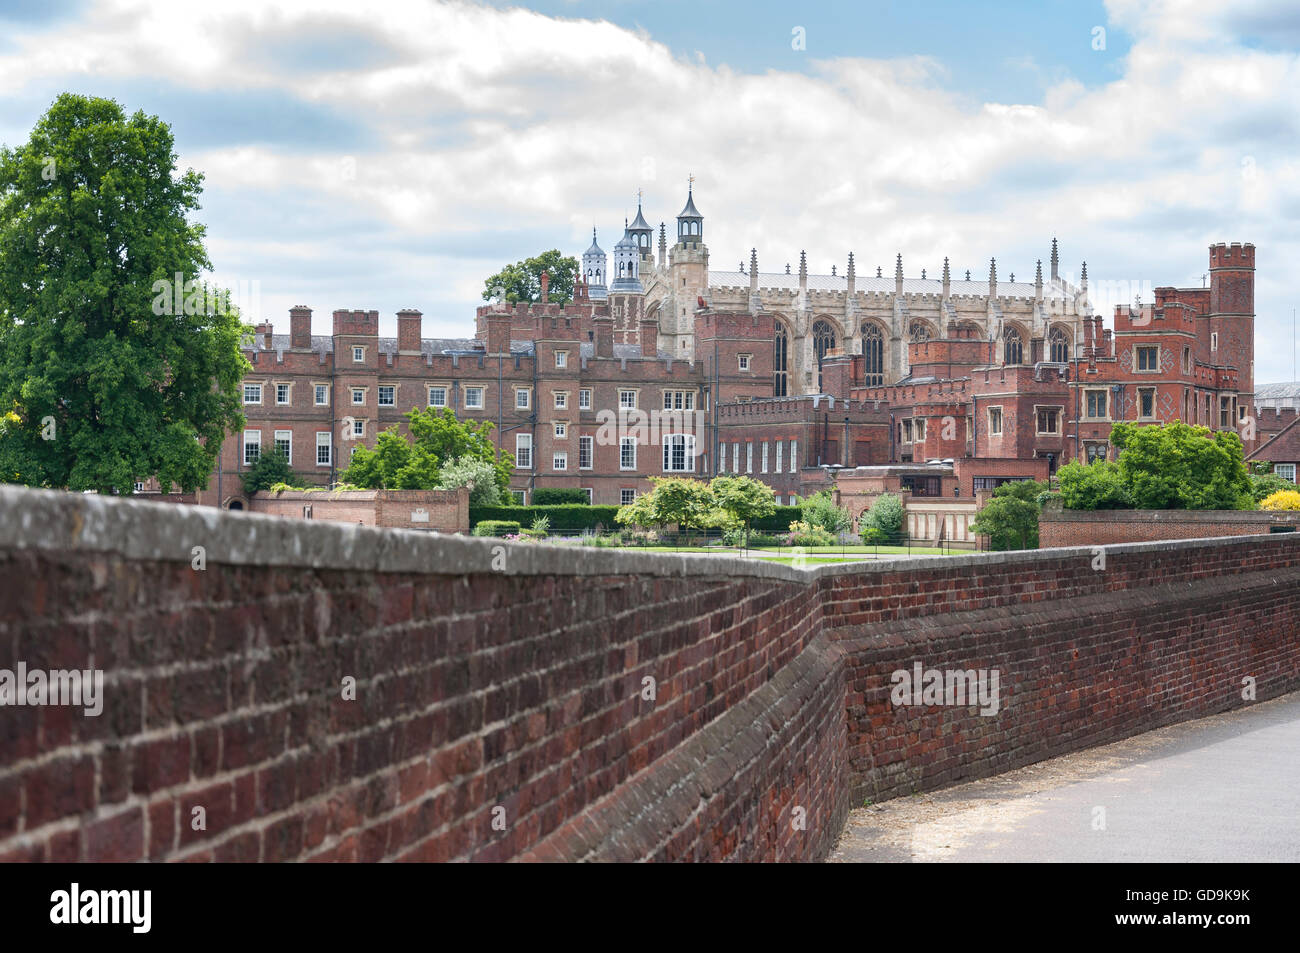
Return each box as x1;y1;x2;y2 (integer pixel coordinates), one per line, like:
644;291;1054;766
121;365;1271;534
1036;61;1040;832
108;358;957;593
823;534;1300;803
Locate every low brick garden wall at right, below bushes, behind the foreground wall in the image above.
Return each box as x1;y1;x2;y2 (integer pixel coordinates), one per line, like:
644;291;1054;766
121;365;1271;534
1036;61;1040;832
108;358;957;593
1039;510;1300;549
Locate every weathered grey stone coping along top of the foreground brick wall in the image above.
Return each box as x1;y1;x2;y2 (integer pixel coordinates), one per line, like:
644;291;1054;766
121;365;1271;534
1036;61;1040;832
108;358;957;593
0;485;1300;582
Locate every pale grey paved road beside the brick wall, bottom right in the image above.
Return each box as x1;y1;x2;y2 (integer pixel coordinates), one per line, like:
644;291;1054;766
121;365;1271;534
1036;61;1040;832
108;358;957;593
831;693;1300;863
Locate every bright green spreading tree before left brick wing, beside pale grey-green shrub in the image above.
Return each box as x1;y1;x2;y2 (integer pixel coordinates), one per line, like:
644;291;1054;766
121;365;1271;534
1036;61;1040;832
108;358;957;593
342;407;515;506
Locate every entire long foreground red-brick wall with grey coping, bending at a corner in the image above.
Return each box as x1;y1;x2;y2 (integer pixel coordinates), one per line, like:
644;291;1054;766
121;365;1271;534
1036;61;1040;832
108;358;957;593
0;488;1300;862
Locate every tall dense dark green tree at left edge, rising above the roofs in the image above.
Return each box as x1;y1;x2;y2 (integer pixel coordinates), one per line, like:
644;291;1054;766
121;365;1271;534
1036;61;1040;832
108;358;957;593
0;94;248;494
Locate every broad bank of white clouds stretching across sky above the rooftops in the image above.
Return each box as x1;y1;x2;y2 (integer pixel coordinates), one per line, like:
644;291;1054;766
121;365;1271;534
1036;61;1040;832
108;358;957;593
0;0;1300;380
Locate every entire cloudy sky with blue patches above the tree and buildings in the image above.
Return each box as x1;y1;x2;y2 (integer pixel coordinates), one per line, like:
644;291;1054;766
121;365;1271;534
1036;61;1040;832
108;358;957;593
0;0;1300;382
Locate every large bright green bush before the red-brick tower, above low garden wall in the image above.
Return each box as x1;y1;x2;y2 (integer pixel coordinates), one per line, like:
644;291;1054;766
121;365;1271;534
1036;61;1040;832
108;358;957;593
1110;420;1255;510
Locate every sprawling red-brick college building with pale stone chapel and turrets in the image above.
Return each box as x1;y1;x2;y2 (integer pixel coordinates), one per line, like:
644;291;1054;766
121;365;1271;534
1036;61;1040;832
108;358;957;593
178;185;1253;504
